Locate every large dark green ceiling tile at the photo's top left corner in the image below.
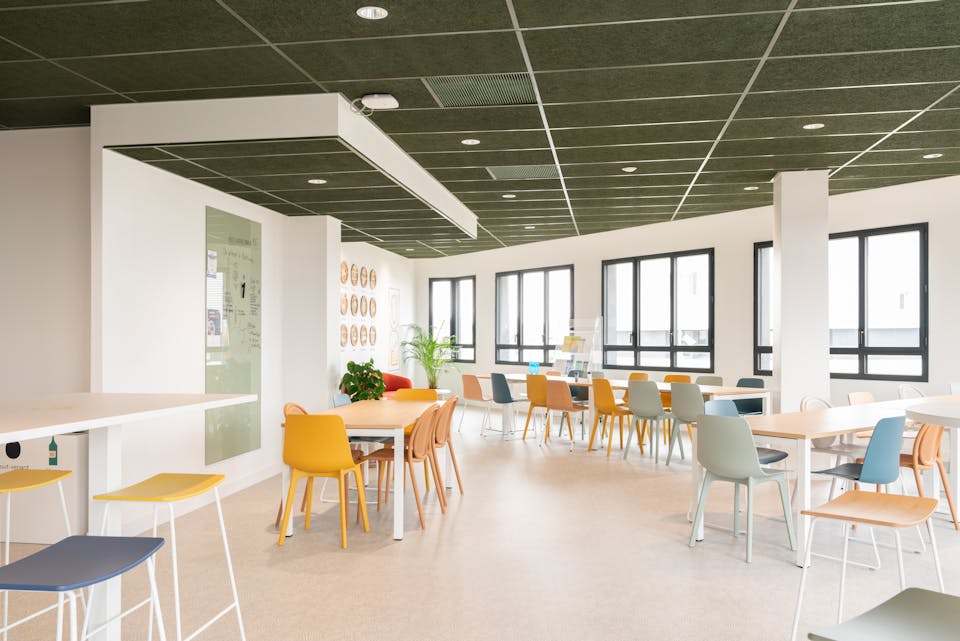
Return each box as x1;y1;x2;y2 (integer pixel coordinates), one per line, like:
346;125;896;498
0;0;261;58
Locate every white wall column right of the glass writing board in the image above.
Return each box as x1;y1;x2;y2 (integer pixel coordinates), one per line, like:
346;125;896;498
283;216;340;404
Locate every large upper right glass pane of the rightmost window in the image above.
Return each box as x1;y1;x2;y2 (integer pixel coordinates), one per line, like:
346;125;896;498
866;231;920;344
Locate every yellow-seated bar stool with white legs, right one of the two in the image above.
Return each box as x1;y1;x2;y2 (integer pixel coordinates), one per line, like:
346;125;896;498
93;474;247;641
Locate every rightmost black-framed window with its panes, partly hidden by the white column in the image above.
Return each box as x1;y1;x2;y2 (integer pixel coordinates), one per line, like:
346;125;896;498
754;224;928;381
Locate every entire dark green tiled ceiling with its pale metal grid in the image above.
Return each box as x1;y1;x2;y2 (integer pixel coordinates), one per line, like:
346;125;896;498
0;0;960;256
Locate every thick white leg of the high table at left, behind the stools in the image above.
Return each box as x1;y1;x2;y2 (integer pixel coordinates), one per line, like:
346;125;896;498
87;425;123;641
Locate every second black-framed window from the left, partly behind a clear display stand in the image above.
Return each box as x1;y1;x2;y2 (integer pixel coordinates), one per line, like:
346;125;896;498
496;265;573;364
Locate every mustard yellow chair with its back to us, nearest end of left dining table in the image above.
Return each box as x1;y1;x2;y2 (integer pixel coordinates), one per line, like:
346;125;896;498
277;414;370;548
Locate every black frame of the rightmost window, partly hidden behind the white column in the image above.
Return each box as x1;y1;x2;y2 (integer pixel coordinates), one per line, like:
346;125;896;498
753;223;930;383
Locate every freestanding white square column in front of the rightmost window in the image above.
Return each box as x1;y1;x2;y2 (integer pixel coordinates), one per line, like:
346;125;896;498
772;171;830;412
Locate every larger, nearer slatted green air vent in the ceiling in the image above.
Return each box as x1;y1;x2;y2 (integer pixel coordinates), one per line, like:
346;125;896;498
423;73;537;107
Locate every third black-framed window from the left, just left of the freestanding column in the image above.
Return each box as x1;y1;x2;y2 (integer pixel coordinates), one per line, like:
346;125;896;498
602;249;713;372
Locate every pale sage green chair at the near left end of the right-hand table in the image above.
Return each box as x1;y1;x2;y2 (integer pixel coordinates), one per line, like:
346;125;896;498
690;414;797;563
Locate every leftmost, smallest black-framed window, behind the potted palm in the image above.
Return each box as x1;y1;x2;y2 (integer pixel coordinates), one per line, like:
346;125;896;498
430;276;477;363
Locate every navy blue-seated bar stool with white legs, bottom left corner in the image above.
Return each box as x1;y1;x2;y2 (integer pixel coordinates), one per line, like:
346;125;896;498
0;536;166;641
